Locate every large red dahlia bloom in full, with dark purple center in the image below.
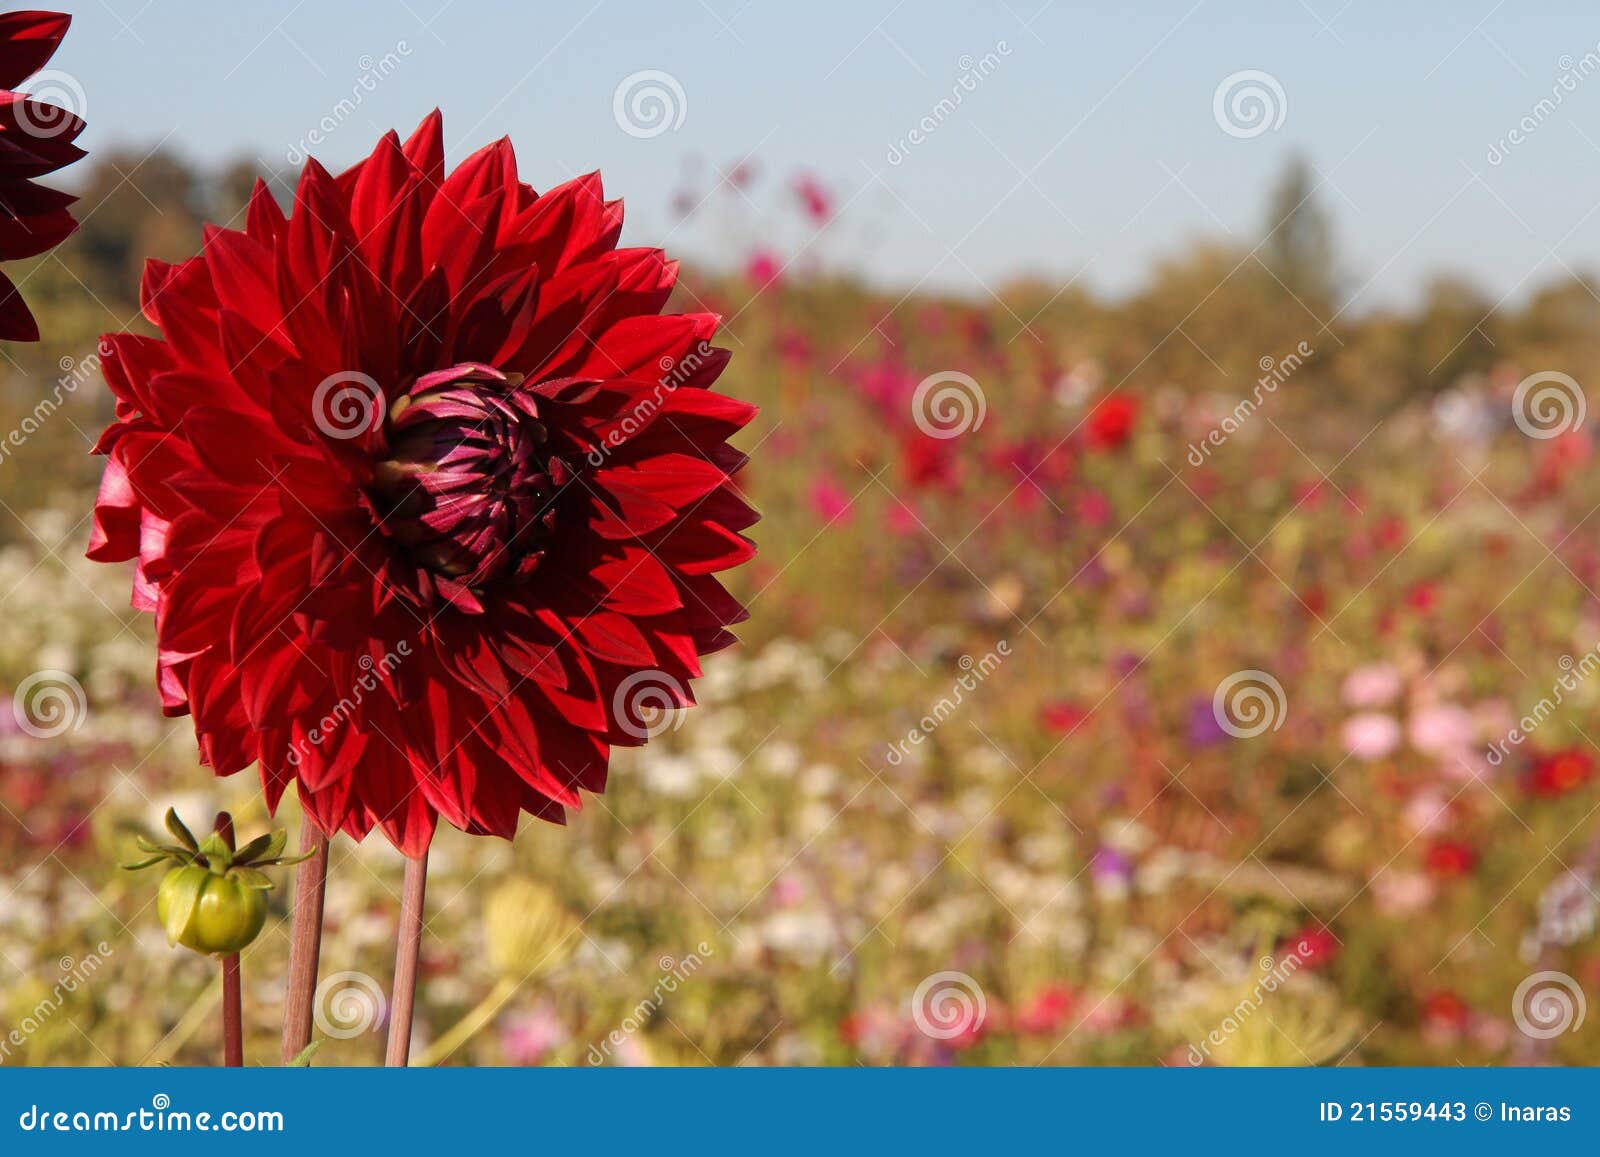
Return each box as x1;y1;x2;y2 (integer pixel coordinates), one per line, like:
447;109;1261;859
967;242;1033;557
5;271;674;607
90;112;755;856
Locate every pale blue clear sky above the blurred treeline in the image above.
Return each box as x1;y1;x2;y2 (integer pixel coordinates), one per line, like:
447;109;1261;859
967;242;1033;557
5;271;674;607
54;0;1600;310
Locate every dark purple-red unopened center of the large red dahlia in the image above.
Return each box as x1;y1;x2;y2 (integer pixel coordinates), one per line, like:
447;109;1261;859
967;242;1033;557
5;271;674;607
374;365;571;587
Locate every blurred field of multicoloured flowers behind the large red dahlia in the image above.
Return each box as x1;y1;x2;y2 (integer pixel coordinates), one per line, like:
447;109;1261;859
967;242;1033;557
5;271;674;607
0;151;1600;1066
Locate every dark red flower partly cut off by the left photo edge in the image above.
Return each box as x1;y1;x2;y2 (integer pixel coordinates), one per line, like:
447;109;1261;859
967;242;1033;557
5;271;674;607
0;11;83;341
